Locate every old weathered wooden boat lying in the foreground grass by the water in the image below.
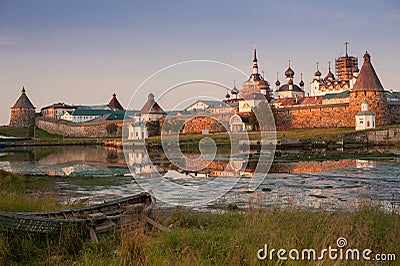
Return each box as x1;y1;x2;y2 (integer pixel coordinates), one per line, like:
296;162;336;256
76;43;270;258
0;193;154;238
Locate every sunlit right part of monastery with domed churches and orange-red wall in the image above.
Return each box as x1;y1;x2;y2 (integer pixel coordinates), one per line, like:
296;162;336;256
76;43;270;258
159;44;400;133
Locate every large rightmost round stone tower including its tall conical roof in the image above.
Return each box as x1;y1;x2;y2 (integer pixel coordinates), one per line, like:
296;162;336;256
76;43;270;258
349;52;390;126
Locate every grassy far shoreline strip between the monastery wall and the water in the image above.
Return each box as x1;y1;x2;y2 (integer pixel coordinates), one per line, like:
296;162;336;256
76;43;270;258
0;124;400;151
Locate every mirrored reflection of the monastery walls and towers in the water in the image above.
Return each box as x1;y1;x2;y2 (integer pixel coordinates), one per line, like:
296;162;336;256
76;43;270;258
0;147;382;177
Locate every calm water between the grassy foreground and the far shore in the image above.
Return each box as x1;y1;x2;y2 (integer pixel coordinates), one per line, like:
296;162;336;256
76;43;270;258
0;146;400;210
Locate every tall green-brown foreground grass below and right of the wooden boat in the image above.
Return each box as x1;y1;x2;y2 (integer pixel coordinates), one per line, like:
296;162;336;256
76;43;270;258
0;205;400;265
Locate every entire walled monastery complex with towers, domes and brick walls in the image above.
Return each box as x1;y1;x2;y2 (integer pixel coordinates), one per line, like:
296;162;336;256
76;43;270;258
10;46;400;140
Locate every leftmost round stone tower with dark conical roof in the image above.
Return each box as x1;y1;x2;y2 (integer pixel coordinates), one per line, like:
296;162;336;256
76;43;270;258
10;87;35;127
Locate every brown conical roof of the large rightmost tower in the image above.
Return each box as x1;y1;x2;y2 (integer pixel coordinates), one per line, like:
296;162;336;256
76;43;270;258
353;52;384;91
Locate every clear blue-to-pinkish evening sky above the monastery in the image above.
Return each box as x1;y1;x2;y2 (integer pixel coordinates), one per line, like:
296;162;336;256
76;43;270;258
0;0;400;124
